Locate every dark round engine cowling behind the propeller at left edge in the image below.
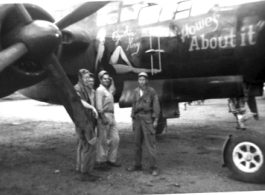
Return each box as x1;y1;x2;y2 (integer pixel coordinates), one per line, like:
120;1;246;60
0;4;54;97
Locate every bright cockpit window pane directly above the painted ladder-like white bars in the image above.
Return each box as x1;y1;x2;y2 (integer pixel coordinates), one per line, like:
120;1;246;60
138;5;162;26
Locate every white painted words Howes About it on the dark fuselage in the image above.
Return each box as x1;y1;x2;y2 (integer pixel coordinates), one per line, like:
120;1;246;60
174;14;265;52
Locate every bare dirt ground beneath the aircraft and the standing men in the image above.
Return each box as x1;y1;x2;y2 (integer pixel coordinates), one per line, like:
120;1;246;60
0;94;265;195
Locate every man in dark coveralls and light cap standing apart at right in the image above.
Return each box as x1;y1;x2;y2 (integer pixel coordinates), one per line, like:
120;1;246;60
127;72;160;176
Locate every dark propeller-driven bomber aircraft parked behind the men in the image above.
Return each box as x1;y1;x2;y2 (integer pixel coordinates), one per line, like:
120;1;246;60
0;0;265;182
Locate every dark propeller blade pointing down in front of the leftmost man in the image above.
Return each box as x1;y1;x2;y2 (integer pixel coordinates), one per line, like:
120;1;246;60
43;54;93;135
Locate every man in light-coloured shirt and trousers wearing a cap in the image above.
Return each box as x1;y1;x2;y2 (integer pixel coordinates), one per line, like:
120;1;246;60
96;70;121;170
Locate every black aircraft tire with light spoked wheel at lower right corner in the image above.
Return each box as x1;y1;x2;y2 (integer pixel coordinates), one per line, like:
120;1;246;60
224;131;265;183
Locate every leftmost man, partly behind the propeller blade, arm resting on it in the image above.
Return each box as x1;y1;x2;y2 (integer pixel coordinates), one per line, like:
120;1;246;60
74;69;98;181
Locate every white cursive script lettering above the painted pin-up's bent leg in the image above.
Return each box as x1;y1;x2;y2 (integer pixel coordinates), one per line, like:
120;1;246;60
112;26;140;56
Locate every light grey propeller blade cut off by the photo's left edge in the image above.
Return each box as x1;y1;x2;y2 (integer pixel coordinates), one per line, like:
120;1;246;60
0;43;28;72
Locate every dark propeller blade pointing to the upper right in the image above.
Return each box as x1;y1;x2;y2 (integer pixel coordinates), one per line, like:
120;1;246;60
56;1;109;30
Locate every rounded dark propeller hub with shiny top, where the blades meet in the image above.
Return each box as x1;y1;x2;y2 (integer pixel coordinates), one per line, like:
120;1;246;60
18;20;62;58
